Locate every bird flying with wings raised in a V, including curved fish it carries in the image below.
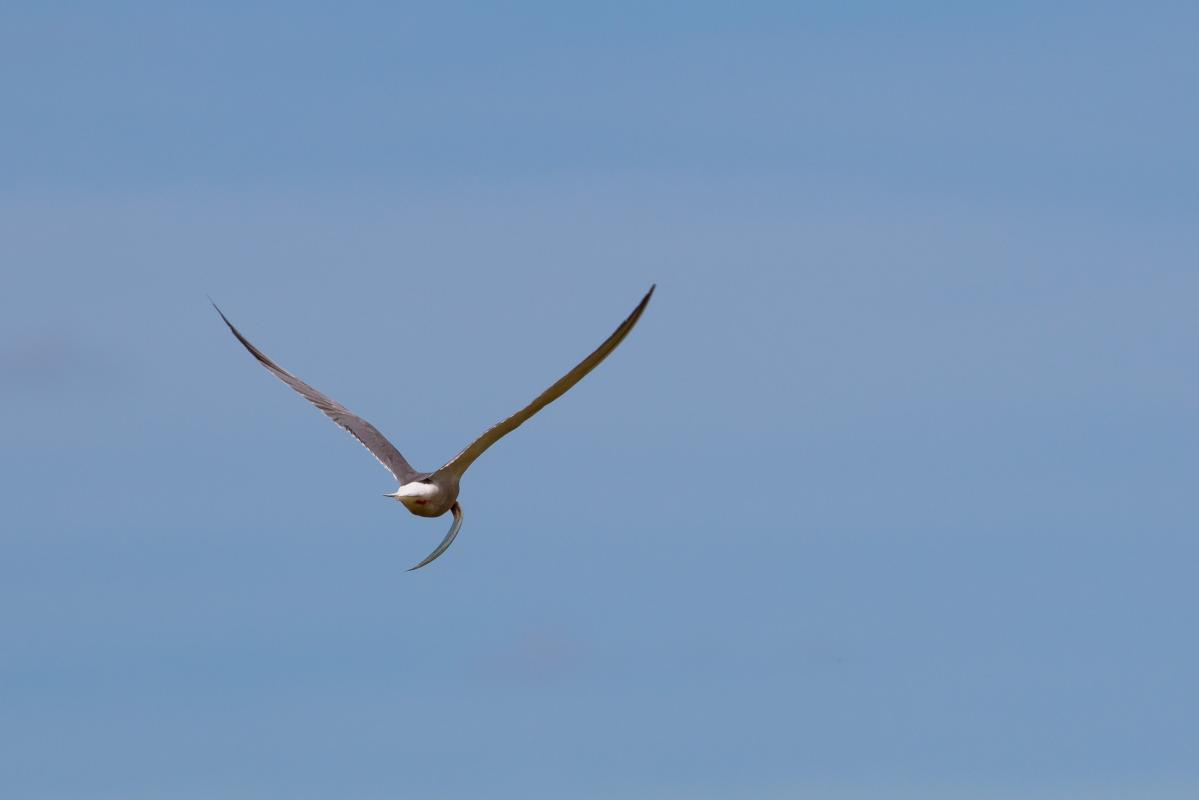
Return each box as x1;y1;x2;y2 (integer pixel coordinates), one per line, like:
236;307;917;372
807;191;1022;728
209;284;657;572
